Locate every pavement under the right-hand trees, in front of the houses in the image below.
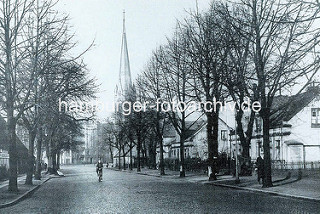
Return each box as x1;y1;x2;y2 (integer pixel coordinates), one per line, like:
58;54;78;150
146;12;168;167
109;168;320;202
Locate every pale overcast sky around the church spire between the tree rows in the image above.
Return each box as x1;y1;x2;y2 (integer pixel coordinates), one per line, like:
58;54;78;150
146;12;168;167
57;0;211;117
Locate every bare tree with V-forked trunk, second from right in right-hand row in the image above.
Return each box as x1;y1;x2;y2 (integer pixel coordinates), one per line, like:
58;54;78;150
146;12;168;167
216;4;259;162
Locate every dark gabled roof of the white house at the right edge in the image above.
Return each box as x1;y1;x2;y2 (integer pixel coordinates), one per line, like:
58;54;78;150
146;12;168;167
270;87;319;127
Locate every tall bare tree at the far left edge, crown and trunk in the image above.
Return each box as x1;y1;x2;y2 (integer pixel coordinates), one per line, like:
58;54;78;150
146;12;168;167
0;0;37;191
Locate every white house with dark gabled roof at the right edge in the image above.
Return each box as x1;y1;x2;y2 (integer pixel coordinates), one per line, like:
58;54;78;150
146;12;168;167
250;87;320;168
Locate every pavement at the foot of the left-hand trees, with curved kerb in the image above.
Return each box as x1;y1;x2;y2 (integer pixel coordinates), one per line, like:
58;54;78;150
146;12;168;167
0;173;52;209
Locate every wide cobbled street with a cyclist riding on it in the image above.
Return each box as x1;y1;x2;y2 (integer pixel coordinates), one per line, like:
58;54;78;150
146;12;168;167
1;165;320;213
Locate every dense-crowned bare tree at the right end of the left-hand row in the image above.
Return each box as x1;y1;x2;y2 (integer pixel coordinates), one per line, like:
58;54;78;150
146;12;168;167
44;61;96;172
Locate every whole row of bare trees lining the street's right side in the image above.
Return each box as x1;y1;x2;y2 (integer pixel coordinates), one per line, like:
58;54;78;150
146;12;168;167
104;0;320;187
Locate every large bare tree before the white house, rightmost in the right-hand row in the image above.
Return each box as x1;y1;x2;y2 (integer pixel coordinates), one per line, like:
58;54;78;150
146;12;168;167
242;0;320;187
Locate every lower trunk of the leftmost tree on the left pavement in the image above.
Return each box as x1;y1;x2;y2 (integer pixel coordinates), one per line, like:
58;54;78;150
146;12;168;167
7;113;18;192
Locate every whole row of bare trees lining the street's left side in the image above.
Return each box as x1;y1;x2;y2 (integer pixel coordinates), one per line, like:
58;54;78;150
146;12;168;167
0;0;95;191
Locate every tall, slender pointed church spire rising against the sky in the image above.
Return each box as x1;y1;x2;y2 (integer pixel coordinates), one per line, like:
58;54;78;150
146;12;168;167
119;11;132;95
